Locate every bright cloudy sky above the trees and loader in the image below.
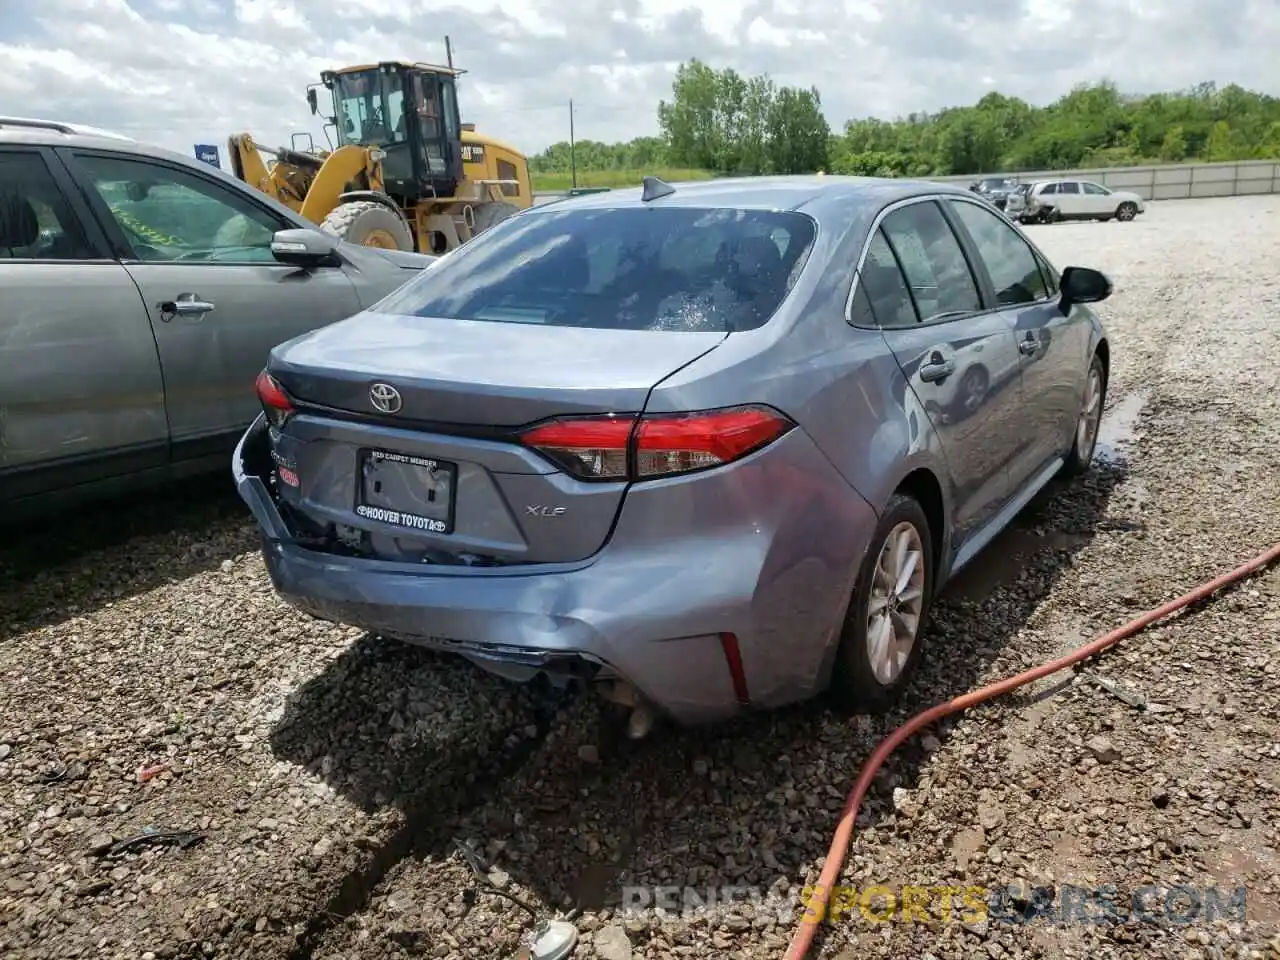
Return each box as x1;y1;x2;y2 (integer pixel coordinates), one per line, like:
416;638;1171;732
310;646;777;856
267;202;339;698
0;0;1280;165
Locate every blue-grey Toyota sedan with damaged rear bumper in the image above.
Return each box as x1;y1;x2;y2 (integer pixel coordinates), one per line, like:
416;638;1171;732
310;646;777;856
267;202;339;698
233;177;1111;735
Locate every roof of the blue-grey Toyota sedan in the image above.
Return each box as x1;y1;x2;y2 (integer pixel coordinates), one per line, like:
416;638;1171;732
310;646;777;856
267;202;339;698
532;174;969;216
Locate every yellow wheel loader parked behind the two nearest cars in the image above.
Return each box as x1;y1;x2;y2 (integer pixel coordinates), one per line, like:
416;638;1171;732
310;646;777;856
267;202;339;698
229;56;534;253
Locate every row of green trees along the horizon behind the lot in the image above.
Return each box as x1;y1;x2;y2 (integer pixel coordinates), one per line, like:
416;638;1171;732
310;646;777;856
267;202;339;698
530;74;1280;183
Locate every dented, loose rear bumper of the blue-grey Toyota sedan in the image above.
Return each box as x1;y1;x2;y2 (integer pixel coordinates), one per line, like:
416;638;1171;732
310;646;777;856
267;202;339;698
233;420;876;723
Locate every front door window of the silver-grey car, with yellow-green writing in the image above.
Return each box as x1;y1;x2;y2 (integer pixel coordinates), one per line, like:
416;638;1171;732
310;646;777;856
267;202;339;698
77;155;291;262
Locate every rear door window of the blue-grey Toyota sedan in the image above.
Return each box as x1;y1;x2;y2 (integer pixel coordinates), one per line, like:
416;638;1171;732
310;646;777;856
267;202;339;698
882;201;982;323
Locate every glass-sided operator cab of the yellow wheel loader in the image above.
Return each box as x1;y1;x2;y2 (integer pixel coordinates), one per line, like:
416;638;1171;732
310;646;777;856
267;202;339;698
321;63;463;204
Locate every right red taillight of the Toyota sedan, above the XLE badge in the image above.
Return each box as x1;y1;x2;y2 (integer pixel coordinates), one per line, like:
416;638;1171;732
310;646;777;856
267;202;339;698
521;406;795;480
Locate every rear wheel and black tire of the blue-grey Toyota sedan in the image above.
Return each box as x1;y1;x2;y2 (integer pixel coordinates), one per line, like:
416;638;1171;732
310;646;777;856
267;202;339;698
832;494;934;713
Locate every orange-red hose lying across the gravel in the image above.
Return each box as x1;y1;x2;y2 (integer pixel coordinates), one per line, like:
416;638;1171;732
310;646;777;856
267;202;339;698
786;543;1280;960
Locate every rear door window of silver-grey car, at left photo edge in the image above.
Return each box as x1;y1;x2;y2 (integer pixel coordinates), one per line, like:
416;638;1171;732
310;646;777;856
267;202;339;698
0;152;95;260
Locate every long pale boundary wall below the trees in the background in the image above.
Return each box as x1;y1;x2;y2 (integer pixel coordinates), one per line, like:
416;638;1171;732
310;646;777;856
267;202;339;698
534;160;1280;204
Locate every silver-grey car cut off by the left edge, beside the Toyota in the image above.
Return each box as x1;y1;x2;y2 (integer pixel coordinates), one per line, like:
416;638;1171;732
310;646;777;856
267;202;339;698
0;118;433;520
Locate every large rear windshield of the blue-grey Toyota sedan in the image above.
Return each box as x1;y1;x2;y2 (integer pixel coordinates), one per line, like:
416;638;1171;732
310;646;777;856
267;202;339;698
374;207;815;332
